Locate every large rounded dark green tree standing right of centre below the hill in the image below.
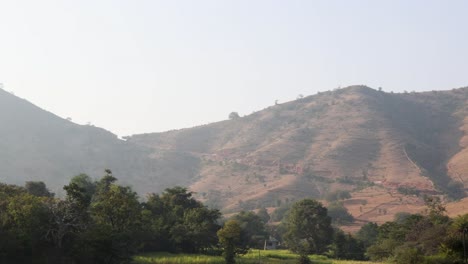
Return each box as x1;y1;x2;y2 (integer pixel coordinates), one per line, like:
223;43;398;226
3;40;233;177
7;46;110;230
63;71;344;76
284;199;333;256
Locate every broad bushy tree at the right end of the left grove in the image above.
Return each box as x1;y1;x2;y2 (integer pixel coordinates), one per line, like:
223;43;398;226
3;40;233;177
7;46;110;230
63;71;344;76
144;187;221;253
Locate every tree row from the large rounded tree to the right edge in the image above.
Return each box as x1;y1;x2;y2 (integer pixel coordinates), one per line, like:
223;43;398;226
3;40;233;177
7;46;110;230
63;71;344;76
272;197;468;264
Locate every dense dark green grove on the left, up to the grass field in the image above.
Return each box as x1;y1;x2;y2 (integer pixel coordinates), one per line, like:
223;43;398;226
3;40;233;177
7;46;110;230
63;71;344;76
0;170;221;264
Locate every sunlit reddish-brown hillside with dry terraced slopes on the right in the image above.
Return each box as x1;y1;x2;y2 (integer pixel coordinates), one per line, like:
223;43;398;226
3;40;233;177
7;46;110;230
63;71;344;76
128;86;468;222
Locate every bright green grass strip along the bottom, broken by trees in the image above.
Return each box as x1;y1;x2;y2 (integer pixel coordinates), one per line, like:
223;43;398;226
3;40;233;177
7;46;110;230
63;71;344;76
134;250;377;264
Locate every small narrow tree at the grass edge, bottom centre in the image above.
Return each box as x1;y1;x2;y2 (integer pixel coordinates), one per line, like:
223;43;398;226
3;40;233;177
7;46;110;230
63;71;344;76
217;220;246;264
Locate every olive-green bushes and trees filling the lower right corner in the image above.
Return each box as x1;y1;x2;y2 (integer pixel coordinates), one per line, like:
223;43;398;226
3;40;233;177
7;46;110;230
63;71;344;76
357;197;468;264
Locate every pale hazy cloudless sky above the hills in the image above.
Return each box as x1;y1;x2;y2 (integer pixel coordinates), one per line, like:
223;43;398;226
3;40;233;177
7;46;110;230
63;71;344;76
0;0;468;136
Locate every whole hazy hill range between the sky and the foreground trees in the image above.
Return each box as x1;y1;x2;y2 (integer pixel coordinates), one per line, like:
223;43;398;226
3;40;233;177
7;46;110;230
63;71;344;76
0;86;468;225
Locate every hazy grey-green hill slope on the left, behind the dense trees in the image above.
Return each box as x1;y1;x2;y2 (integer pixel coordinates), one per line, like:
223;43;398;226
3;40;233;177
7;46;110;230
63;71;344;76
0;89;193;193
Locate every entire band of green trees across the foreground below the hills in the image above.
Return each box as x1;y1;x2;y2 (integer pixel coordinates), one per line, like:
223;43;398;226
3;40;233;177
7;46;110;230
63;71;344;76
0;170;468;264
